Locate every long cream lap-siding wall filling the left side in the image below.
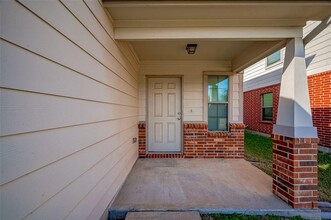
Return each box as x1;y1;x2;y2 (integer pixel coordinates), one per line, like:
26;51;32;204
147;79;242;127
0;0;139;219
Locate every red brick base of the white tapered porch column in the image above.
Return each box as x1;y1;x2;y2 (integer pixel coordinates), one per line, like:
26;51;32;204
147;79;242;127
272;134;318;209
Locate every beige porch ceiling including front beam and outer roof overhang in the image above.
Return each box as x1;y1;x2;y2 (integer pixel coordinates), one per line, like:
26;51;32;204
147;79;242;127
104;0;331;72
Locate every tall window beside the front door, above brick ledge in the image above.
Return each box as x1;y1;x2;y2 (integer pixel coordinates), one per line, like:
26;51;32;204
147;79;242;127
208;75;229;131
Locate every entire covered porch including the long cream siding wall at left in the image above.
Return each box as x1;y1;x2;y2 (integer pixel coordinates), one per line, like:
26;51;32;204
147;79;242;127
0;0;331;219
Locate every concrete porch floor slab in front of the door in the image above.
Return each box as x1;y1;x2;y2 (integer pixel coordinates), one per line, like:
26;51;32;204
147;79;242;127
110;159;319;219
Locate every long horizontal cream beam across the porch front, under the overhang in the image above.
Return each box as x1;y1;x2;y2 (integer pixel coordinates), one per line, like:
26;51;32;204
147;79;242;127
115;27;302;41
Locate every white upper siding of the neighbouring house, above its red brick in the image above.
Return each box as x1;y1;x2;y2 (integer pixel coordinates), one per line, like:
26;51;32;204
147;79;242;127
244;21;331;92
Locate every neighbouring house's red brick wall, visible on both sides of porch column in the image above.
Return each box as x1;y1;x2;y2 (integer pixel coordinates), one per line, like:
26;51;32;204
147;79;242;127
244;71;331;148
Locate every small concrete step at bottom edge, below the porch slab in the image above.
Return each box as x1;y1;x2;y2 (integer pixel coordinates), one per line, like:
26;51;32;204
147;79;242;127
125;212;201;220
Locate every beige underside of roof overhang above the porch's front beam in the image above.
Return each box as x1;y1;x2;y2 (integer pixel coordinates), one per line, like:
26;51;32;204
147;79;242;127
104;0;331;27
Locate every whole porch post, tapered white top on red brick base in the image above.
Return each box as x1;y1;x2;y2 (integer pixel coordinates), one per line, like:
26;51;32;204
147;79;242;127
272;38;318;208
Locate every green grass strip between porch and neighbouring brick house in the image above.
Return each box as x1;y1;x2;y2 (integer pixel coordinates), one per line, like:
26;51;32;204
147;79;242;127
245;132;331;202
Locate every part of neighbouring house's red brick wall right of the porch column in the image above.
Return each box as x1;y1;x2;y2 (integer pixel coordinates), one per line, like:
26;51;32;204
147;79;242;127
308;71;331;148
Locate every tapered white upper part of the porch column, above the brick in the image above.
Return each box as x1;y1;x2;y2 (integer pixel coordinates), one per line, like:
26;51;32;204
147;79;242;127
273;38;317;138
